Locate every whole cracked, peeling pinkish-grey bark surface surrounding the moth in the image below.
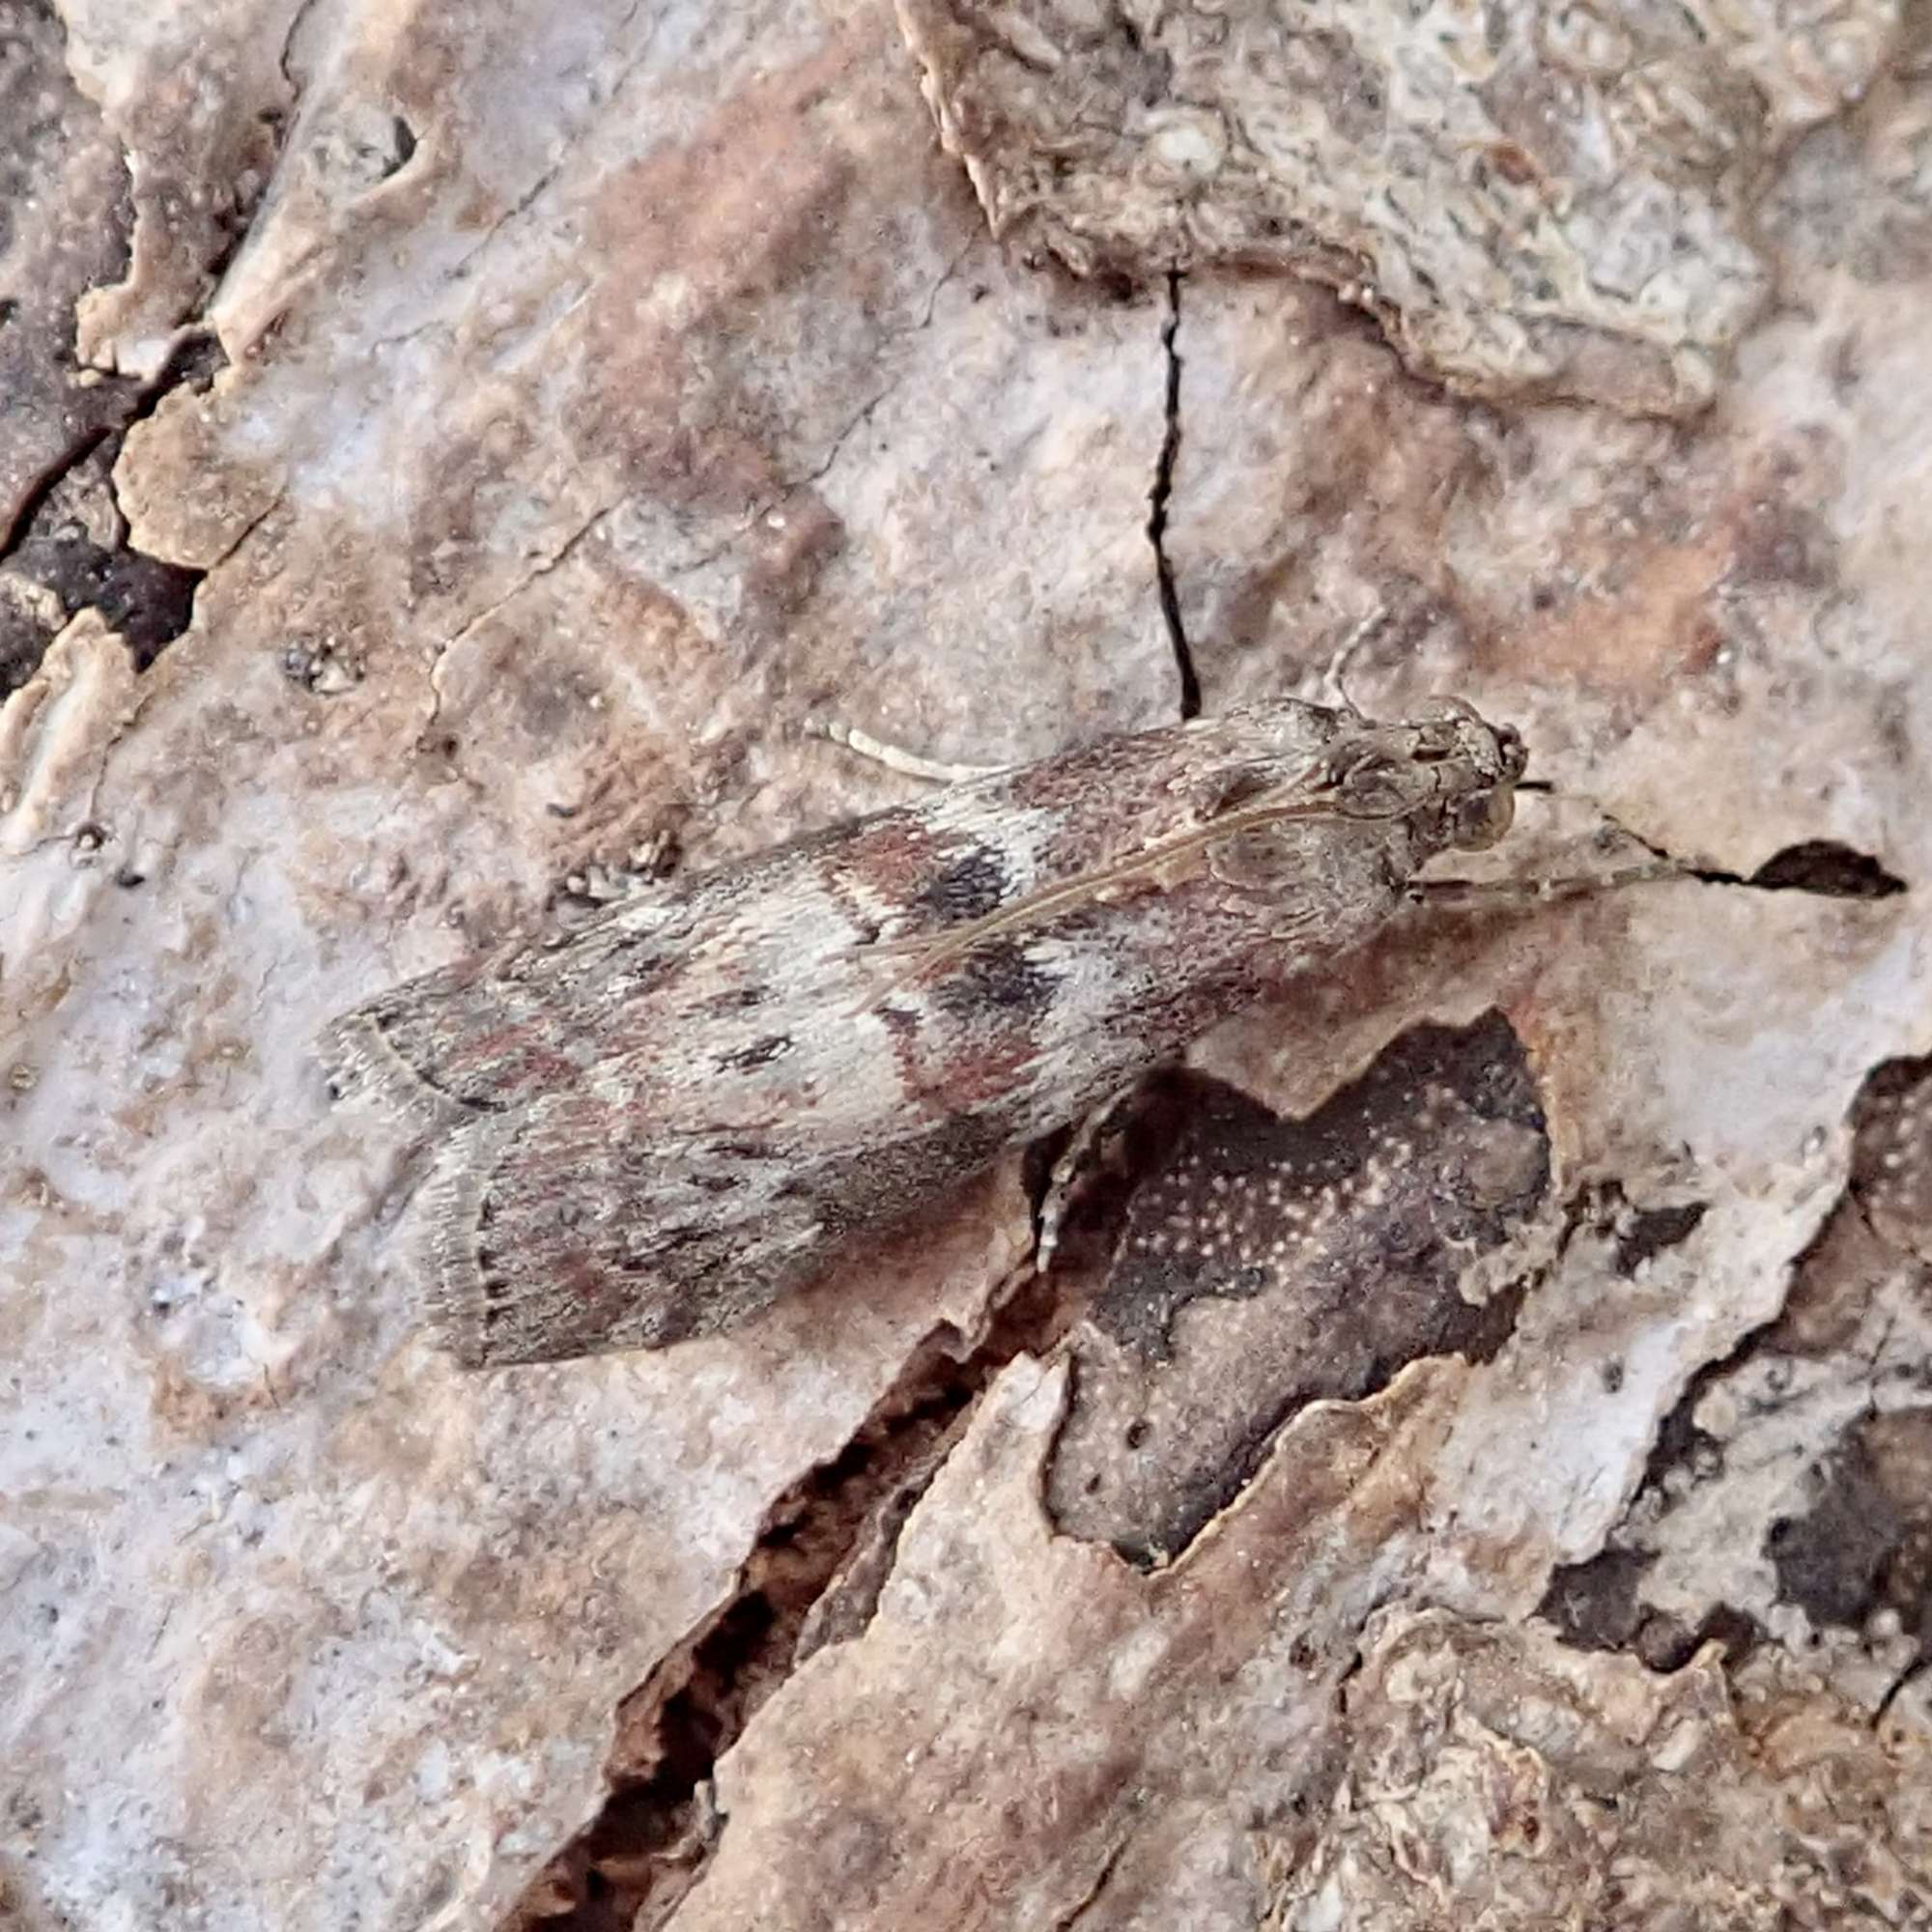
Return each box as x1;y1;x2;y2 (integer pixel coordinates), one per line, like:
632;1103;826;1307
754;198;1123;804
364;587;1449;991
0;0;1932;1932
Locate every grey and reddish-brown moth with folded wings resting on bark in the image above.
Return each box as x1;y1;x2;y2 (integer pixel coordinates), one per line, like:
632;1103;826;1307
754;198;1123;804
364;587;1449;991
323;699;1524;1366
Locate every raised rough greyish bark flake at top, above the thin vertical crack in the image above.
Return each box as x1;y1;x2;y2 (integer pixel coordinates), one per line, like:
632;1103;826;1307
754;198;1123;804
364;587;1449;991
898;0;1899;415
